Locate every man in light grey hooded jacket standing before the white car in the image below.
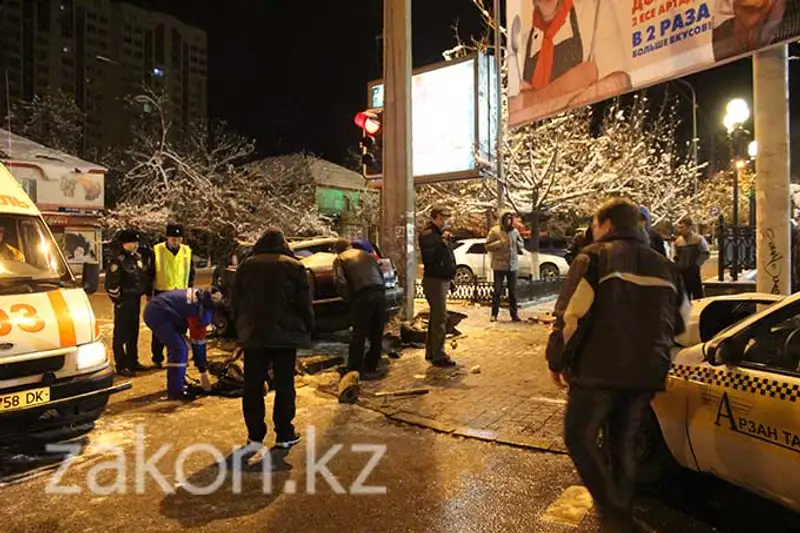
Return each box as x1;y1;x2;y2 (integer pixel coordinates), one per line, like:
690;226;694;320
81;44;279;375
486;209;524;322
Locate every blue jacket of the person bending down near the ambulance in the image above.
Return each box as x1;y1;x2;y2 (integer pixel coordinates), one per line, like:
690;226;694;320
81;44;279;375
144;288;214;331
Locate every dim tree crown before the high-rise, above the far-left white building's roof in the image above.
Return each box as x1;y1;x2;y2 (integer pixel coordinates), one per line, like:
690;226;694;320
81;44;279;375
11;90;86;155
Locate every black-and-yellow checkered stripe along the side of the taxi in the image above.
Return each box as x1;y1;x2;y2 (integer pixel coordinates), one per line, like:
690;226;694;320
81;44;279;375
669;365;800;402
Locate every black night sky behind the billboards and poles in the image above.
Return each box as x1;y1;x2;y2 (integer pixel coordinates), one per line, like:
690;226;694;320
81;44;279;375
128;0;800;170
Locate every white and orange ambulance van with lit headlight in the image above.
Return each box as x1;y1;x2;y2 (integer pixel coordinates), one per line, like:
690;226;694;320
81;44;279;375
0;164;131;446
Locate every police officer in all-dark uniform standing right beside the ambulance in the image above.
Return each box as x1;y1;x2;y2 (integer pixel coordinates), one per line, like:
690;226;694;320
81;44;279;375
105;230;147;377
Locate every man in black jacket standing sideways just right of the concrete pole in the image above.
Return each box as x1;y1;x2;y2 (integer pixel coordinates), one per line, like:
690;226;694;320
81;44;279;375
419;206;456;367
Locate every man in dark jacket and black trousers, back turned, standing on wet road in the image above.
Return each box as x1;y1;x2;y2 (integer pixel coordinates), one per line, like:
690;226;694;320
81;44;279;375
231;224;314;462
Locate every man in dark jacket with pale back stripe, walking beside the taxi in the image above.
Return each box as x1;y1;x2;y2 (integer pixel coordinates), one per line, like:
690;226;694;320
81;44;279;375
547;198;688;531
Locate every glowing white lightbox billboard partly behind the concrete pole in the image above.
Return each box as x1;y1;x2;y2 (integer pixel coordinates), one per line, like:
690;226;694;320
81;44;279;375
367;55;496;182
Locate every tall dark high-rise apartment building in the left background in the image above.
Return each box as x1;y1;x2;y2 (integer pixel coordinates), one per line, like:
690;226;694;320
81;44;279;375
0;0;208;148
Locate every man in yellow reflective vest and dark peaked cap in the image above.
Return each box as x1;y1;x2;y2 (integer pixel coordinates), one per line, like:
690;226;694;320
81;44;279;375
149;223;194;368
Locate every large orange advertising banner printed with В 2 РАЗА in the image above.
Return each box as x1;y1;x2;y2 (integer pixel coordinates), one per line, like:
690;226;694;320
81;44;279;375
507;0;800;127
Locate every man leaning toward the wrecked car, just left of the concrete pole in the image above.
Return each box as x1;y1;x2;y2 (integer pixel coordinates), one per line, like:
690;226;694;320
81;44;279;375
333;239;386;379
